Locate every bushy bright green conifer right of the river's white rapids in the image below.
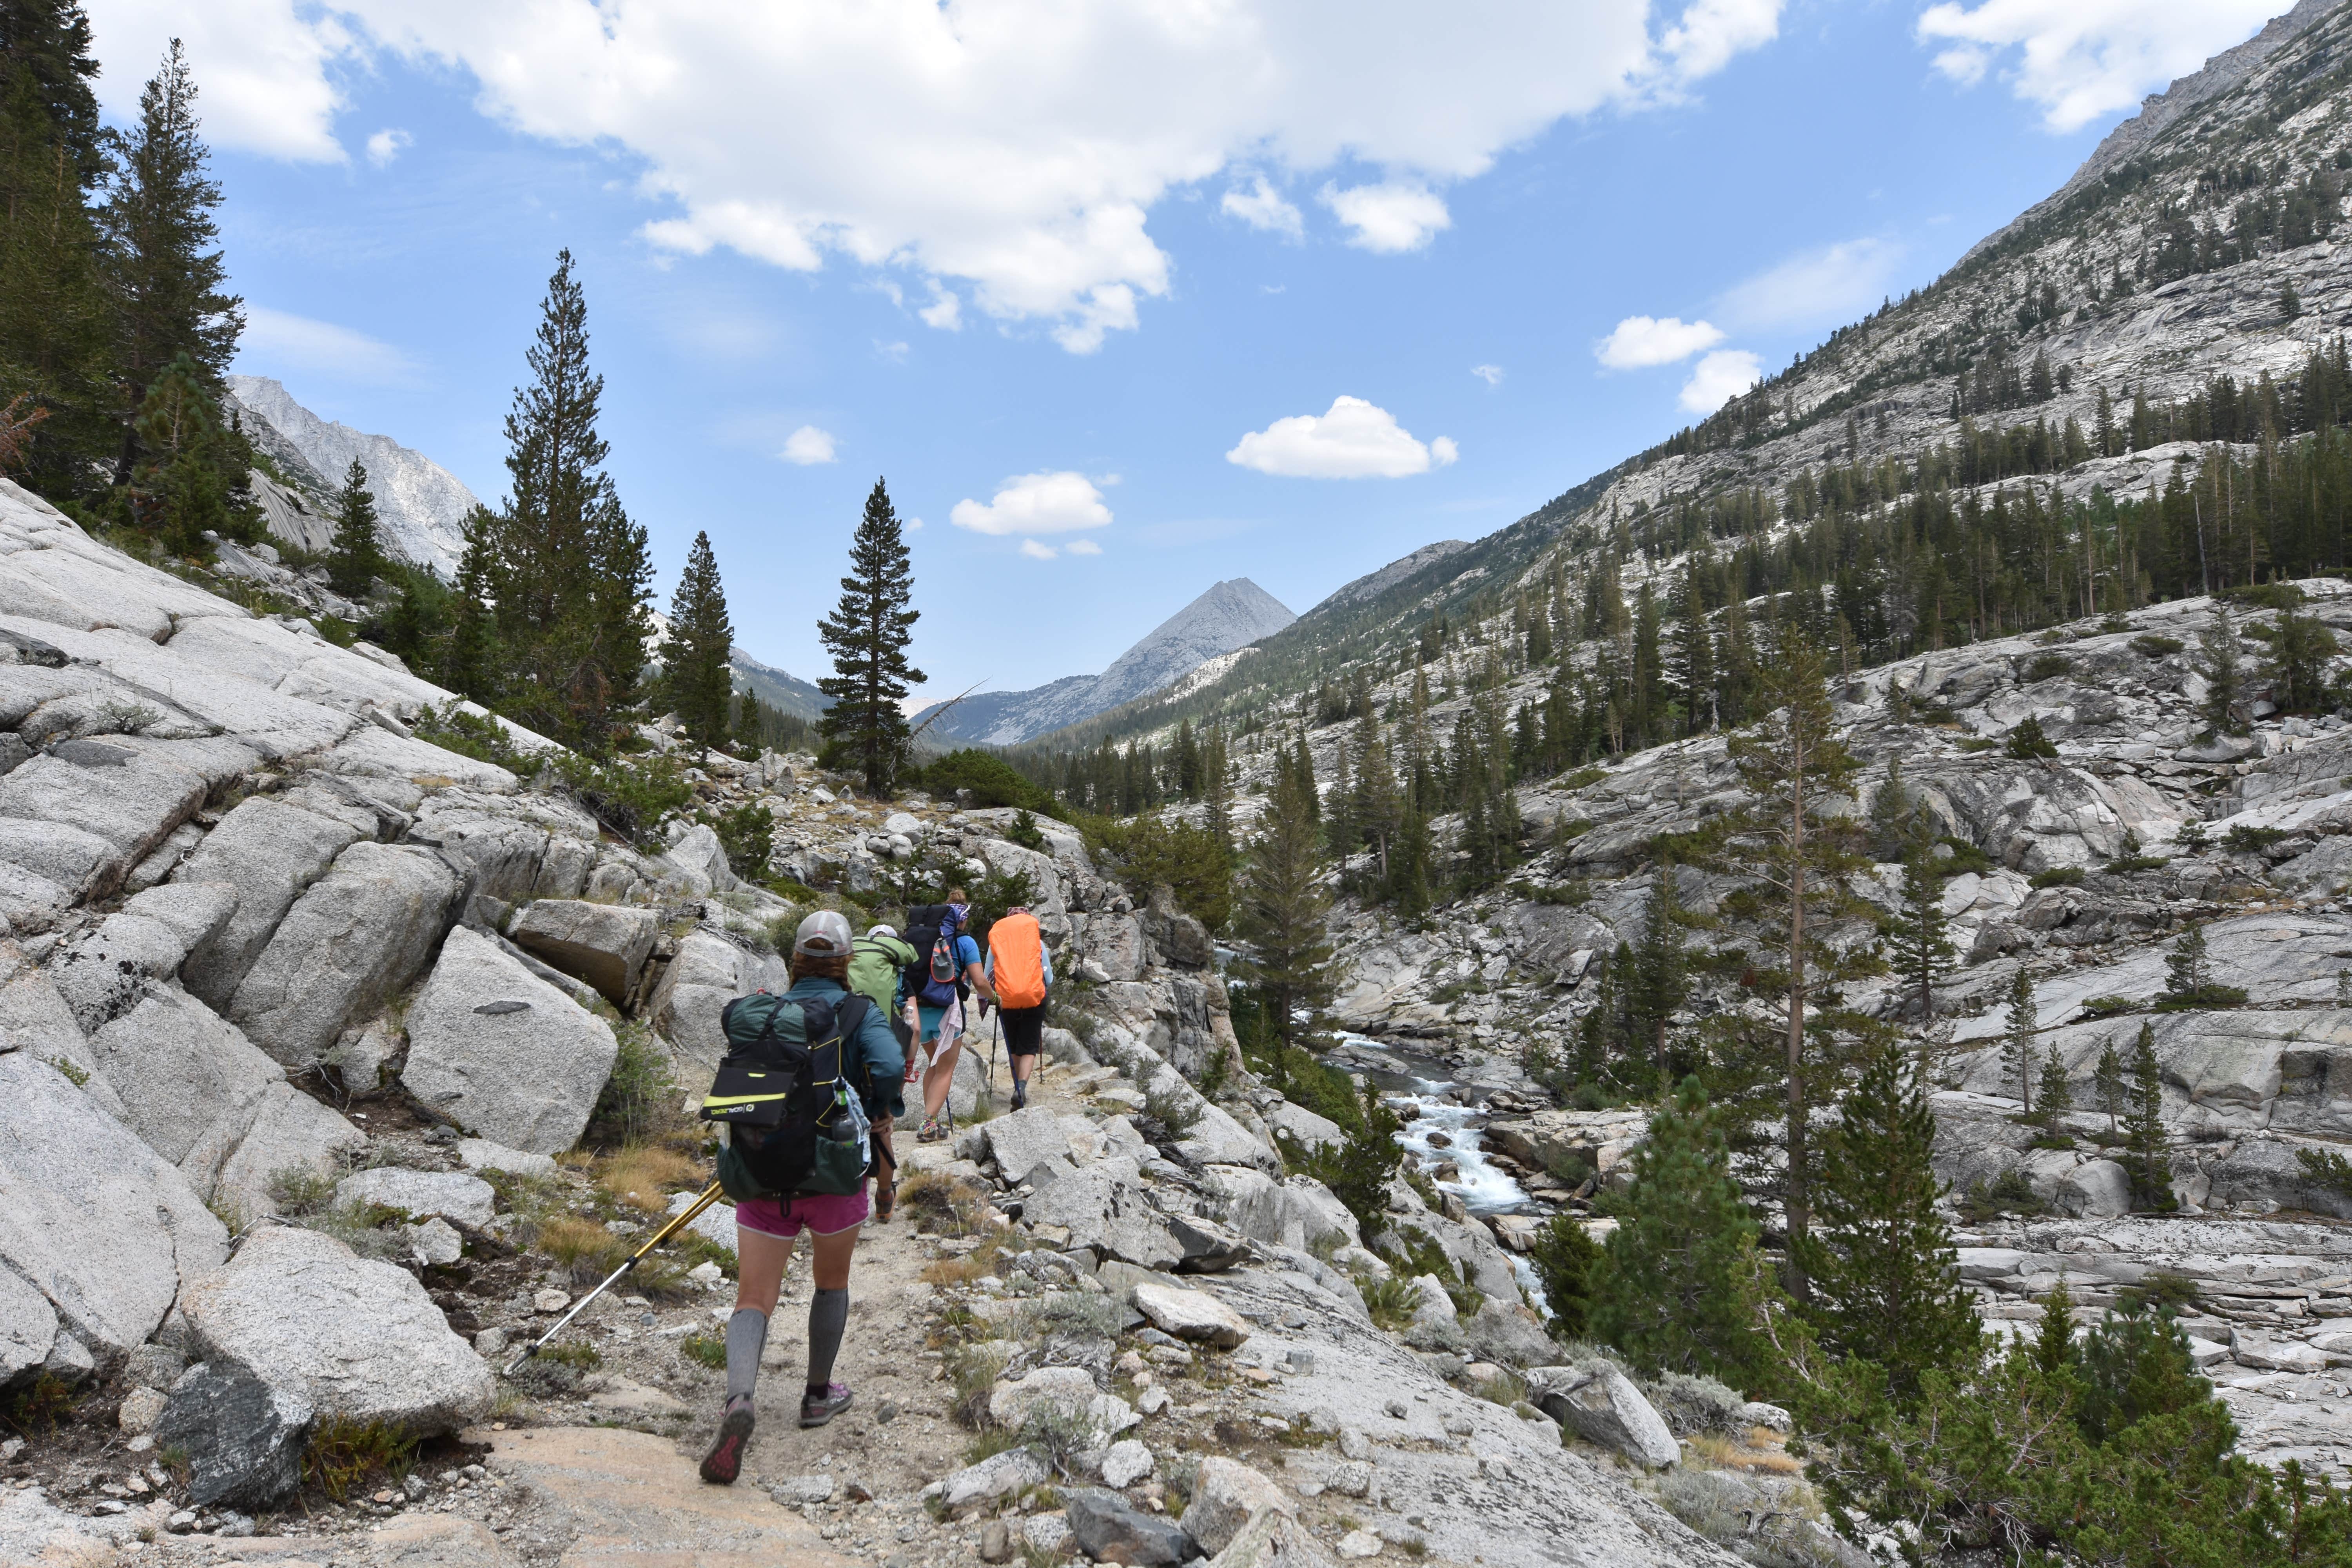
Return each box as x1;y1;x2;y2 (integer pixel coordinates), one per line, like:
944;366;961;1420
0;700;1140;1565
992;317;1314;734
1590;1079;1757;1385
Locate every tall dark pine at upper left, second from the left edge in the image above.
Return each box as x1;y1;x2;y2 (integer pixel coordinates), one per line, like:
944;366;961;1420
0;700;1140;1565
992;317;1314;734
99;38;245;484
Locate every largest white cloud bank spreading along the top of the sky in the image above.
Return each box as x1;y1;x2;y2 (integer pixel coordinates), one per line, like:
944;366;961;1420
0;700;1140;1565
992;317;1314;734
92;0;1783;353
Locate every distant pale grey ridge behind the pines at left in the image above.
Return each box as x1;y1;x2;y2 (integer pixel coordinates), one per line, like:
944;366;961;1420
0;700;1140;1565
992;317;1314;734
228;376;477;581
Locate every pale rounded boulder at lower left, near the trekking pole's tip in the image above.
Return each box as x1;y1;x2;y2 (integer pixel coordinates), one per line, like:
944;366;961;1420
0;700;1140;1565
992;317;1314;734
181;1225;496;1434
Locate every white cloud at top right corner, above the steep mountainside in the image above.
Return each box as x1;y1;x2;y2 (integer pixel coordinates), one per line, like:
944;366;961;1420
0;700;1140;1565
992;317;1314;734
1919;0;2286;132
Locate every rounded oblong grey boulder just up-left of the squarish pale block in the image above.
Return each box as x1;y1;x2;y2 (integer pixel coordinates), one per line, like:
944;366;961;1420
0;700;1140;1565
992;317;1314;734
228;842;463;1070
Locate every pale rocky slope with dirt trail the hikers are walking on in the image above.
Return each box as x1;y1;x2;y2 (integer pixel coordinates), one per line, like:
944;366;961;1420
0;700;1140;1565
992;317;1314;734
0;482;1797;1568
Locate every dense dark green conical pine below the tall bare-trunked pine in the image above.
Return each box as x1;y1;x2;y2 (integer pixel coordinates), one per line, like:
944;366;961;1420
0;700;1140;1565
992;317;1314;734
1802;1039;1980;1401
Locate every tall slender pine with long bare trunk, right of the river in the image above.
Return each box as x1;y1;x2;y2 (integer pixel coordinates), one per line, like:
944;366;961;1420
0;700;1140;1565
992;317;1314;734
1726;632;1865;1298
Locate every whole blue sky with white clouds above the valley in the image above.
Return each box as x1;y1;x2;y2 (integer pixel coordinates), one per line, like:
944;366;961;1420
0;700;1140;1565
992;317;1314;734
85;0;2284;696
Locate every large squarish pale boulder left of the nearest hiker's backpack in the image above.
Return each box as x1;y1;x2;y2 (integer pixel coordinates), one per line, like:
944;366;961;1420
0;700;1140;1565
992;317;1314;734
400;929;621;1154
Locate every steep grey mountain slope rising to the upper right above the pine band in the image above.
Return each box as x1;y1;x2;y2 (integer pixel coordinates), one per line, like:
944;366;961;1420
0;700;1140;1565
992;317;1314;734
1047;0;2352;750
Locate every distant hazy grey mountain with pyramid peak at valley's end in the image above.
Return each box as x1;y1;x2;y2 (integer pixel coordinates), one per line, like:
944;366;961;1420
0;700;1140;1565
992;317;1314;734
915;578;1296;745
